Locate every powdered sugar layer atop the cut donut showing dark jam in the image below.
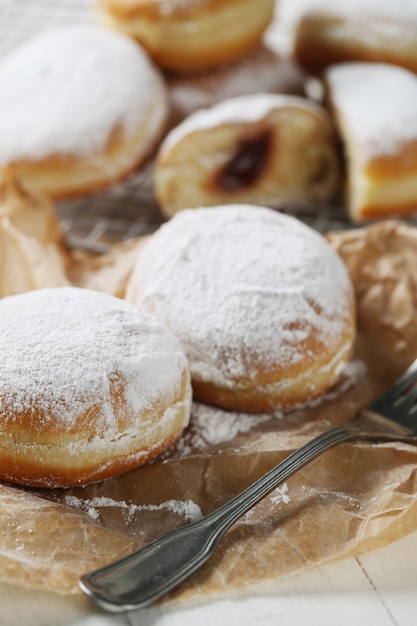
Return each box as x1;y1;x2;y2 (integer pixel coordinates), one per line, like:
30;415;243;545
160;93;326;156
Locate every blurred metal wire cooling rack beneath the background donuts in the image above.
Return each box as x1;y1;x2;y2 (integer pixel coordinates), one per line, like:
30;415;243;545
0;0;351;252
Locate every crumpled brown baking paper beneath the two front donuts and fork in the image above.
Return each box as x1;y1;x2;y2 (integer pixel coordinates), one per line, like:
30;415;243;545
0;216;417;599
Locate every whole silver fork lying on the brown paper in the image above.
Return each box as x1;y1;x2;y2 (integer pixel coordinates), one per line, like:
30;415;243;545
79;359;417;612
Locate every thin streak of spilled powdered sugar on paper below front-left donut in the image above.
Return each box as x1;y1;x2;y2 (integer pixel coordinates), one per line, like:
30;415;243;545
64;496;203;522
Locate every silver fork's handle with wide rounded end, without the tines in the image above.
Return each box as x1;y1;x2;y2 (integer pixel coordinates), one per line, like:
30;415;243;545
79;422;362;612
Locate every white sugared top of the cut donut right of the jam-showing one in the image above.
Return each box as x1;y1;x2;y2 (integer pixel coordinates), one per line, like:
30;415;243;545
326;62;417;156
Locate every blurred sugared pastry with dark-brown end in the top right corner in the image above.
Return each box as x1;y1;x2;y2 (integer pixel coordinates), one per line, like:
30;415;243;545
294;0;417;73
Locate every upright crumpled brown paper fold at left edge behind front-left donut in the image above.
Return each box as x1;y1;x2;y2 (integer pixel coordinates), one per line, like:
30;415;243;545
0;167;70;298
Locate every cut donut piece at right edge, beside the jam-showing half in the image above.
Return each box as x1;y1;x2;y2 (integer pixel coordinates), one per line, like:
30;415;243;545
325;63;417;222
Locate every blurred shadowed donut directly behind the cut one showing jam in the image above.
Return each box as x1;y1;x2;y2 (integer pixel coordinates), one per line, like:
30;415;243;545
167;45;307;126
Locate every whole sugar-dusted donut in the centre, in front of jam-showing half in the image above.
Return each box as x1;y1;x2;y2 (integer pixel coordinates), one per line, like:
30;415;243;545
126;206;355;412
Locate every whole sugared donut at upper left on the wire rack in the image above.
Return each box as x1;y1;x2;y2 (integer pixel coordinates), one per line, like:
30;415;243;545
0;26;168;198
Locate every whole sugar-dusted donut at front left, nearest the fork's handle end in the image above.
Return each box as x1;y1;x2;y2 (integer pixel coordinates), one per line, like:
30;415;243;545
0;287;190;487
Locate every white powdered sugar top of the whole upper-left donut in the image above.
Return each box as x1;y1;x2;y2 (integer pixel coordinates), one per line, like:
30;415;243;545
0;26;163;164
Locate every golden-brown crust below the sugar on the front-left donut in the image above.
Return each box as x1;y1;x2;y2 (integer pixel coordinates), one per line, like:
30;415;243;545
0;374;189;488
